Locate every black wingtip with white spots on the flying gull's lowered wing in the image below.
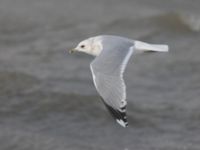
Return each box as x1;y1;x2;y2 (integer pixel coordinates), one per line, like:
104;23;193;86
101;97;128;127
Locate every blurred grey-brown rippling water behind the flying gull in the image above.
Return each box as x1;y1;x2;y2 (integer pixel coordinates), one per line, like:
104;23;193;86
0;0;200;150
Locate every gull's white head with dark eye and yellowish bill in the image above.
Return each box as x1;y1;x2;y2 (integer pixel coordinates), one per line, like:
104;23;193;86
69;37;102;56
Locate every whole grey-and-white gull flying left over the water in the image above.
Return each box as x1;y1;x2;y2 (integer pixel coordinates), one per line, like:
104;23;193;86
69;35;168;127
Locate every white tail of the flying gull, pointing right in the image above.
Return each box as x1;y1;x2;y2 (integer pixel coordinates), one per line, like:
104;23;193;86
134;41;169;52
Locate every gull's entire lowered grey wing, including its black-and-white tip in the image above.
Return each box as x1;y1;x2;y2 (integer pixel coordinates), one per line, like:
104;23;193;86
90;46;133;127
